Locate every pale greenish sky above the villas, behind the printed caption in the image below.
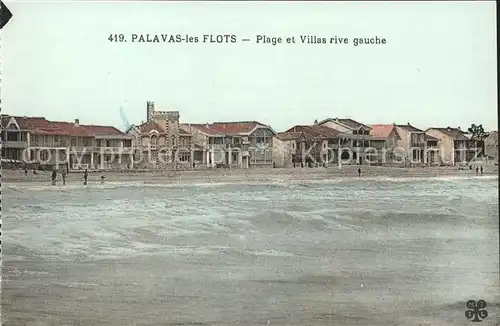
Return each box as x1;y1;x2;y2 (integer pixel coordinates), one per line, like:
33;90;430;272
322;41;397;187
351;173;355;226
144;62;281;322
0;1;498;131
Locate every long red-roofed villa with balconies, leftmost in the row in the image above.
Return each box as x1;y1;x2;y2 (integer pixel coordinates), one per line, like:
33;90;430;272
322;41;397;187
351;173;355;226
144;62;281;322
1;115;133;169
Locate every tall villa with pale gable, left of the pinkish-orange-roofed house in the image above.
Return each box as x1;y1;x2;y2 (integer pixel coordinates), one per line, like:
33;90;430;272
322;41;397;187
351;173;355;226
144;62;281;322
316;118;373;164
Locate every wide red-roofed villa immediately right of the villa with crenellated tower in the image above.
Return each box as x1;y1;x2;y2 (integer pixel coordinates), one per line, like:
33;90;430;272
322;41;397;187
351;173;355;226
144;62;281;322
182;121;276;168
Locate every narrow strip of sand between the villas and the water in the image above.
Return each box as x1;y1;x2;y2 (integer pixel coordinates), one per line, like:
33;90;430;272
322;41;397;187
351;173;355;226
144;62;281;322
2;166;498;183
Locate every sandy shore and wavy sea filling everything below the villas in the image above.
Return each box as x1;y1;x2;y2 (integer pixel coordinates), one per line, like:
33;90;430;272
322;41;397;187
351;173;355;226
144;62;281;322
2;167;500;326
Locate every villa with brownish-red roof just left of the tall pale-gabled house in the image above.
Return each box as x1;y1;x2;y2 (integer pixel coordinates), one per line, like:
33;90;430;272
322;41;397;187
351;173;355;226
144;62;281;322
280;125;341;167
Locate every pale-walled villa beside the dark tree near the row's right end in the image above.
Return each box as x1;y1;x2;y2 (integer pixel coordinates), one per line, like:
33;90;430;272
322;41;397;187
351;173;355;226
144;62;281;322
425;127;481;165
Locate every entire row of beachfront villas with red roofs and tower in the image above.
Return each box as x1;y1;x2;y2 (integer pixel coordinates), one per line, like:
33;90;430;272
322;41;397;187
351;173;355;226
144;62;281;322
1;102;498;169
